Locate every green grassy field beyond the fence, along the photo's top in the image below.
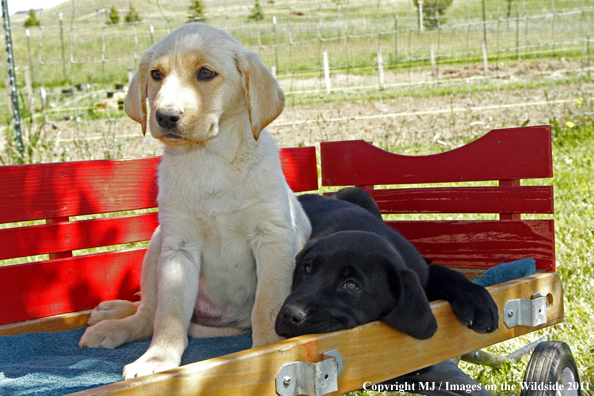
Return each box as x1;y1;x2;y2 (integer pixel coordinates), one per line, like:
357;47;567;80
0;0;594;89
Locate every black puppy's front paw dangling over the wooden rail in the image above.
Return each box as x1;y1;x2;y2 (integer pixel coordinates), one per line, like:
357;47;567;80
449;284;499;333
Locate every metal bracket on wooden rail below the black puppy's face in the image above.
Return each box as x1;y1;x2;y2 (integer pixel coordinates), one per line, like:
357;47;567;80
276;349;342;396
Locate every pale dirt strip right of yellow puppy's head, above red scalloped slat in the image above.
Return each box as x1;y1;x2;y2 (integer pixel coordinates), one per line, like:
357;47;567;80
269;84;594;149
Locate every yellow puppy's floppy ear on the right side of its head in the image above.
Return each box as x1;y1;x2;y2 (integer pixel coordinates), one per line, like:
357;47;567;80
237;51;285;140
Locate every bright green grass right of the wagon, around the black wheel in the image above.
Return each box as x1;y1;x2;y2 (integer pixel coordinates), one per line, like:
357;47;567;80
350;116;594;396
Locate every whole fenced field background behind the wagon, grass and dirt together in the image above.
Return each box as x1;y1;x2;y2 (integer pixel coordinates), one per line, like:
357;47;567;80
0;0;594;162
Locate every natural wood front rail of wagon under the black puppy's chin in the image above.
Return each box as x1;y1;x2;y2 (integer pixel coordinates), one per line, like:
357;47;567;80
72;273;563;396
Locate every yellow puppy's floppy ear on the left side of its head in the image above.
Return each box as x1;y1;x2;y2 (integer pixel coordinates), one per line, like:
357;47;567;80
124;49;153;135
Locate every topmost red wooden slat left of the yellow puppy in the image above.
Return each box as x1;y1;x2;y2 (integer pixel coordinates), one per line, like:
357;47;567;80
0;157;160;223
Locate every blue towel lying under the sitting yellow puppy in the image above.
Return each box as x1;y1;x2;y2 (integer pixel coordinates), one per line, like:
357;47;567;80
0;328;252;396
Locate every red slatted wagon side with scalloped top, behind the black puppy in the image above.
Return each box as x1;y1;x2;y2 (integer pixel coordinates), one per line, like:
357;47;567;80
321;126;555;271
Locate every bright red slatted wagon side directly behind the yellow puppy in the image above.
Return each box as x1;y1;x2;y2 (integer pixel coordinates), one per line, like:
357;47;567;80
0;147;318;324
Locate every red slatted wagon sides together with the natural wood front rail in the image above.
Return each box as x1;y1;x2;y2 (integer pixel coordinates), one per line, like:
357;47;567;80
0;127;563;395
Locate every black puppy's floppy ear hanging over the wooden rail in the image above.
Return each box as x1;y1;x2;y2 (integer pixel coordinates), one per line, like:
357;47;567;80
380;270;437;340
